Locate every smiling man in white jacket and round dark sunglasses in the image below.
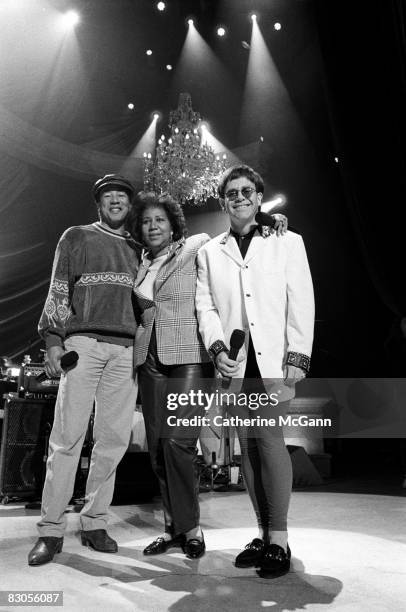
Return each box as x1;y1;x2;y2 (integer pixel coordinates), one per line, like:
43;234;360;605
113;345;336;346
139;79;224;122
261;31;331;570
196;165;314;577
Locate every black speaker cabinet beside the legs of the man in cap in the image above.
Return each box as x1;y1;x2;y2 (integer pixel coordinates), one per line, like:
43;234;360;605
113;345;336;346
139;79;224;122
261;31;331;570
0;398;55;503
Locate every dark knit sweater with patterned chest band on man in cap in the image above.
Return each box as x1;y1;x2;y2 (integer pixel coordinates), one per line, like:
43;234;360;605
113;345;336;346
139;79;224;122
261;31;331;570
38;223;139;348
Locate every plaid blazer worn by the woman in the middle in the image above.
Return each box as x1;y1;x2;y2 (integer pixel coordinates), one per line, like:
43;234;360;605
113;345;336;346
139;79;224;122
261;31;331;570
134;234;210;367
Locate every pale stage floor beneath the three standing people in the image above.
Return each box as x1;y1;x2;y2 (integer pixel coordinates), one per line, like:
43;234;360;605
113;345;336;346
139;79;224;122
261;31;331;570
0;485;406;612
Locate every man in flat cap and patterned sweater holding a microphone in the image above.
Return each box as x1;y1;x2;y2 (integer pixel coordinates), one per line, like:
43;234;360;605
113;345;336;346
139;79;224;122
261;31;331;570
28;174;139;565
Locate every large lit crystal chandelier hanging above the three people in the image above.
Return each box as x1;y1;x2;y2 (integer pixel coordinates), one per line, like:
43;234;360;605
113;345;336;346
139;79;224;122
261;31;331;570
144;93;226;206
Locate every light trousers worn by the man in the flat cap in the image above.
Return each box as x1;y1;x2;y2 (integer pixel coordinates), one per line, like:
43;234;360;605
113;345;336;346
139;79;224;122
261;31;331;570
38;336;137;537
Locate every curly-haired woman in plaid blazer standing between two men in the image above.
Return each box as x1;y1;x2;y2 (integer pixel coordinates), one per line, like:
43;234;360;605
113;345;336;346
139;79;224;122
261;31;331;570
132;193;214;558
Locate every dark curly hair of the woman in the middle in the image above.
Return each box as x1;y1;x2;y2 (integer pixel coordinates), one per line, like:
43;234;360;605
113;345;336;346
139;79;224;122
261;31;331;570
128;191;187;243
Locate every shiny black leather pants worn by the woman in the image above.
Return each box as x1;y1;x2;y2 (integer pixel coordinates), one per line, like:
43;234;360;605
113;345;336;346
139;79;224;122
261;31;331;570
139;334;213;536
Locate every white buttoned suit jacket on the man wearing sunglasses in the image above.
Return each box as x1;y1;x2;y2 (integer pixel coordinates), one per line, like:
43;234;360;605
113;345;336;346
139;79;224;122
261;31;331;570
196;227;314;379
